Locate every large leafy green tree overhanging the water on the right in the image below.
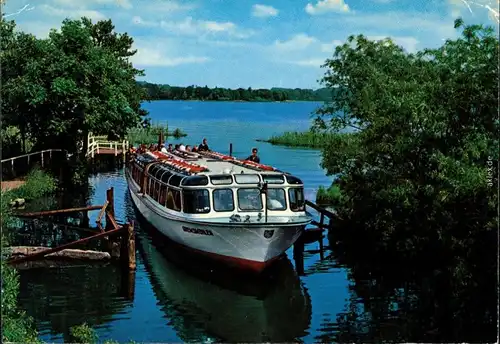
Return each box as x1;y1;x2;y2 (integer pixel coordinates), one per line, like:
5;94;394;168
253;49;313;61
315;20;499;340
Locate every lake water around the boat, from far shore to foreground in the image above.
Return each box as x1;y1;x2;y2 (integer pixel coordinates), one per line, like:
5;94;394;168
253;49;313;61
13;101;495;343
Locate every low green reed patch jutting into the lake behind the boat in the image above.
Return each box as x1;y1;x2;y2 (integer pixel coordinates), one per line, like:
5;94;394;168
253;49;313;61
257;130;332;148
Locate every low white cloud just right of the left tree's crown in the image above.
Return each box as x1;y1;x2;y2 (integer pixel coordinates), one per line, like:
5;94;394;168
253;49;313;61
131;47;210;67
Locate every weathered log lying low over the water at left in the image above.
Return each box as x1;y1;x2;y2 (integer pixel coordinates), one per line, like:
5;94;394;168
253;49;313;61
10;246;111;260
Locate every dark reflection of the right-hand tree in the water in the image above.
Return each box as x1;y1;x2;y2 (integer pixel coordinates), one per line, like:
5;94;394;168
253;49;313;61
316;227;497;343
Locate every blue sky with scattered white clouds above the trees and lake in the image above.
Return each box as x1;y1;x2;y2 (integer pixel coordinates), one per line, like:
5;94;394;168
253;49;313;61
3;0;498;89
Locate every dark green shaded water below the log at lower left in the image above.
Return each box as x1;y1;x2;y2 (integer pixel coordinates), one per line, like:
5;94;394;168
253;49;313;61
19;264;130;342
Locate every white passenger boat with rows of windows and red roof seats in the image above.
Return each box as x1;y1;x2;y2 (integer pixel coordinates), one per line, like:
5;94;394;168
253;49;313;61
126;152;312;272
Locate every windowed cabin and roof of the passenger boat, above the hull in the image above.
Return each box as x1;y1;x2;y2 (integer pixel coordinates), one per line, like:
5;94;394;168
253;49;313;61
128;154;305;217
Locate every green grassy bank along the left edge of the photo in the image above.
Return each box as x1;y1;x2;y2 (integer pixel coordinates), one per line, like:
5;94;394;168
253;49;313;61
0;169;56;343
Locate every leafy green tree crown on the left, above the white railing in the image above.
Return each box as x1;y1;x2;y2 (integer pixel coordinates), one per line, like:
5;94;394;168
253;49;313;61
0;18;146;151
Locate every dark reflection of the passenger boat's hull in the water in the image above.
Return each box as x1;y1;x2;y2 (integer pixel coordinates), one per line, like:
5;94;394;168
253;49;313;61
132;197;312;343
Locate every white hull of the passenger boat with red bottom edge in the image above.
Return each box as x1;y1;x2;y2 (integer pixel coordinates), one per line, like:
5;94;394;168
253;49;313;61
128;180;306;271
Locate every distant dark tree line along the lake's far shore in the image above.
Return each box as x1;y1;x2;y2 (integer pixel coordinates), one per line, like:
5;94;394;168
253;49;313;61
139;82;332;102
